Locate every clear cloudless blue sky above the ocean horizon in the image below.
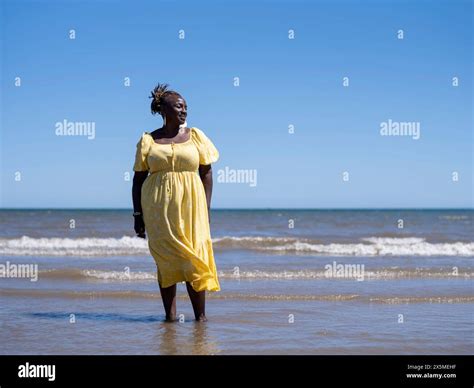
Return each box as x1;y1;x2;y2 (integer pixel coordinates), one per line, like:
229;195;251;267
0;0;473;208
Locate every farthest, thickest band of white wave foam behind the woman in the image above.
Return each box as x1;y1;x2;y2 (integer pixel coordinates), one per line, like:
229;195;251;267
0;236;474;256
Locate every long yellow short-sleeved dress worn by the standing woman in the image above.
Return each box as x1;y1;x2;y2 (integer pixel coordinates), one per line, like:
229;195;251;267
133;127;220;291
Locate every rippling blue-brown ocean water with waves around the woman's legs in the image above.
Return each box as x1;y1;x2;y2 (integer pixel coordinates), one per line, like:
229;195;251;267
0;209;474;355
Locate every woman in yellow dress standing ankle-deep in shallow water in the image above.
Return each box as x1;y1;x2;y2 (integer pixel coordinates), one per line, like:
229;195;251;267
132;84;220;321
